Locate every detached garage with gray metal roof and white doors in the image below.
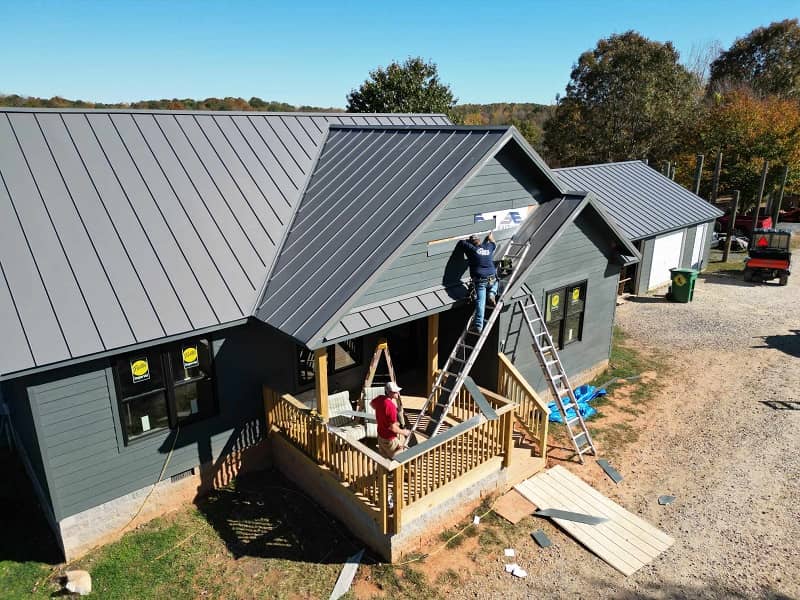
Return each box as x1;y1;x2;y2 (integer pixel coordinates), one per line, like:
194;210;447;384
555;160;722;294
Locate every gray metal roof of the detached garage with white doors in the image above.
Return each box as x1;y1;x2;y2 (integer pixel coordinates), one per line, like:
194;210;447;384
554;160;722;240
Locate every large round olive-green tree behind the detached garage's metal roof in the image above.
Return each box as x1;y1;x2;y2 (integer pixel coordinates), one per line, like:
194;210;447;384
544;31;702;165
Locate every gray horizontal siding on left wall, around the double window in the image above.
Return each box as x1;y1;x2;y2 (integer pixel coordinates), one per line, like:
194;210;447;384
27;324;296;519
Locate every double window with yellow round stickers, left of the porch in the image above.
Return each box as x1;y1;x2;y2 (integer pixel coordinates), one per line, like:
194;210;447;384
113;339;217;445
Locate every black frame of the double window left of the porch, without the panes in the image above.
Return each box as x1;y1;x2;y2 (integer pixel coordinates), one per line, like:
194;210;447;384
111;336;219;446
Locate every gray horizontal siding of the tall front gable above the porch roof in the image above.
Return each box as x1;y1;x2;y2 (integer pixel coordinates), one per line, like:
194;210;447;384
355;144;544;306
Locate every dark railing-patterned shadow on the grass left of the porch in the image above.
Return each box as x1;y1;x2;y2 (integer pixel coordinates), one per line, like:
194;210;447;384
196;470;363;564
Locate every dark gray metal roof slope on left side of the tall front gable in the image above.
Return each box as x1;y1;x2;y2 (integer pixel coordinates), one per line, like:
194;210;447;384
257;126;511;346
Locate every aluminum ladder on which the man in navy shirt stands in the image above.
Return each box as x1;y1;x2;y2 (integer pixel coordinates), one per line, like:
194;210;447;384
411;241;530;438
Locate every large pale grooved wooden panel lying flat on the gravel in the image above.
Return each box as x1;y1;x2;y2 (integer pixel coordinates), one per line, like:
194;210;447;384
514;466;675;575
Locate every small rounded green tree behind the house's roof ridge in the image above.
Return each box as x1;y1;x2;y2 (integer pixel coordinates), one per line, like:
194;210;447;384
347;57;456;115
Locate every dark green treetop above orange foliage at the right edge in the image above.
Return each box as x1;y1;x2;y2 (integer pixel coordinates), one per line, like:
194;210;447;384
709;19;800;98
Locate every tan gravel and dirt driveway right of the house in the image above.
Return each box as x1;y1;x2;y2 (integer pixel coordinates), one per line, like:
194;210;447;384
406;264;800;599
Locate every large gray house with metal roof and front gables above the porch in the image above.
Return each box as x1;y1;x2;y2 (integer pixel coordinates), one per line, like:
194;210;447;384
0;109;638;558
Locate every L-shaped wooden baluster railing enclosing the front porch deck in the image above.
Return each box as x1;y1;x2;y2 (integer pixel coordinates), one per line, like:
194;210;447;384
264;387;514;534
